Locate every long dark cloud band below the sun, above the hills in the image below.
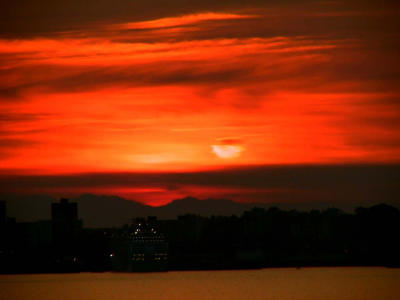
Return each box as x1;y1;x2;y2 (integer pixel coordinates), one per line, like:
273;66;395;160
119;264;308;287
0;165;400;205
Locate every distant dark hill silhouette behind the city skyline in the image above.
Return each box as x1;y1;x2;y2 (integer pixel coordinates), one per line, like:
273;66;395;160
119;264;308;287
0;194;390;228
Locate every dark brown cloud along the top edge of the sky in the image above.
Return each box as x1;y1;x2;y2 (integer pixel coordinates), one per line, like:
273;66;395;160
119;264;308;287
0;0;398;37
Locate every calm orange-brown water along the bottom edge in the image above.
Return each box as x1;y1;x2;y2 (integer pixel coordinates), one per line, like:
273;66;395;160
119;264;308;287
0;268;400;300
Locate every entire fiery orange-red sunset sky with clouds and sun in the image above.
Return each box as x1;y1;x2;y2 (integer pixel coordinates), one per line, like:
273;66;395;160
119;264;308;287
0;0;400;205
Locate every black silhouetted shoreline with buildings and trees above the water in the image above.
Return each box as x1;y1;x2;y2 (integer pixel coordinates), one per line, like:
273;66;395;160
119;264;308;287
0;200;400;273
